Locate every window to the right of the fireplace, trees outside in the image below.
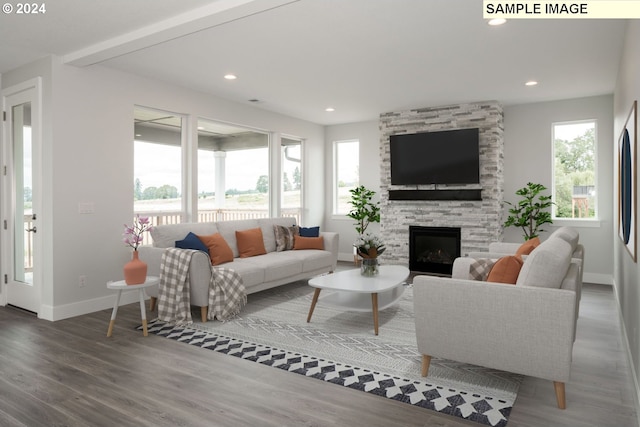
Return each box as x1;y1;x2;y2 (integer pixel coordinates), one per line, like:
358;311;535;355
553;120;597;219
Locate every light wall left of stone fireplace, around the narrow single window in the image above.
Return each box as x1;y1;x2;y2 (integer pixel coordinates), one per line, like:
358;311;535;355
324;120;380;261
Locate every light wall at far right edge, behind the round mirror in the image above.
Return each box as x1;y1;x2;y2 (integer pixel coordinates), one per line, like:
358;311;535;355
610;20;640;403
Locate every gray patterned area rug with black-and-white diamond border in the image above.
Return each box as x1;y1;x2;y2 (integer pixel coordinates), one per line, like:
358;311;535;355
149;282;522;426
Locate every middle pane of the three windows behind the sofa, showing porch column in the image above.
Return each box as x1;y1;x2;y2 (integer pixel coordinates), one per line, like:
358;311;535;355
198;119;270;222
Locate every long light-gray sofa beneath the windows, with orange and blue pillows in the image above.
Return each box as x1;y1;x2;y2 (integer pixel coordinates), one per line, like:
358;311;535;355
138;218;338;322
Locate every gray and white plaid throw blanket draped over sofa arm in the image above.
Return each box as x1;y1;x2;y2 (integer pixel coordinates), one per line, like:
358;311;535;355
158;248;247;325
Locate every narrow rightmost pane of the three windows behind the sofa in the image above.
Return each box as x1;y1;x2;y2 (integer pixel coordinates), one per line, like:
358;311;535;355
280;137;302;224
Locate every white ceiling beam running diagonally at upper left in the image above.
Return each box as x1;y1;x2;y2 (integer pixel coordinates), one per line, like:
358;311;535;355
63;0;299;67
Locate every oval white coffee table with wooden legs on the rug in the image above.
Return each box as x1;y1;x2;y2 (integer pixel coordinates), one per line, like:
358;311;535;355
307;265;410;335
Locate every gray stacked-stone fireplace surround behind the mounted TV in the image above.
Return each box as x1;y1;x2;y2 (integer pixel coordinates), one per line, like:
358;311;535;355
380;101;504;265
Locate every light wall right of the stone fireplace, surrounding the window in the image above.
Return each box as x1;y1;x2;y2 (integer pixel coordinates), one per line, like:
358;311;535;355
504;95;614;284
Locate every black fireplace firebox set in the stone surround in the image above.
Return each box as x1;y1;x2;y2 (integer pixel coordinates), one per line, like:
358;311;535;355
409;225;460;276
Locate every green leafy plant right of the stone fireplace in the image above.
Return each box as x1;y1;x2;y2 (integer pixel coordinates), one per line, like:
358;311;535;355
504;182;554;240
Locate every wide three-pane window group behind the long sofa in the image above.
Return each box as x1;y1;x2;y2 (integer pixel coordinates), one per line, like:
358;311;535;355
133;106;302;234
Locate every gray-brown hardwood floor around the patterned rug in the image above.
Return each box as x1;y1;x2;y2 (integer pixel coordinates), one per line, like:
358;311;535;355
0;285;638;427
